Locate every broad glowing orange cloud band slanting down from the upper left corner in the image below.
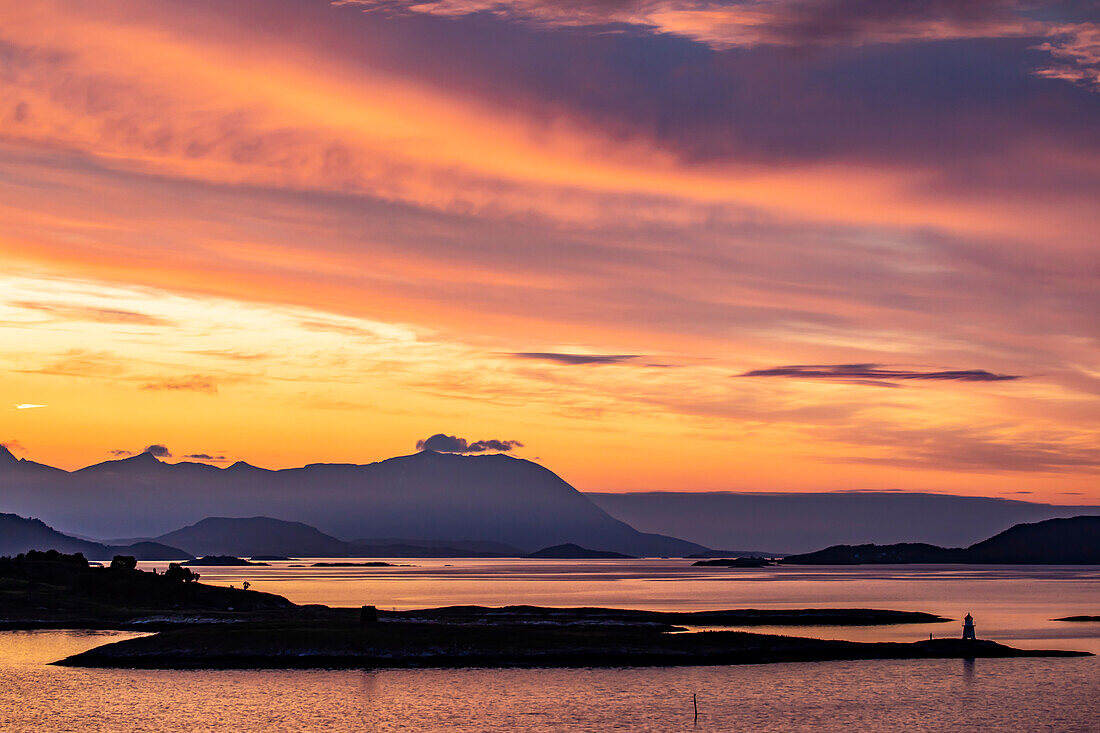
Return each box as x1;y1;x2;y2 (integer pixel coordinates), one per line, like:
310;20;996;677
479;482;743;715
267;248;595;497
0;3;1082;242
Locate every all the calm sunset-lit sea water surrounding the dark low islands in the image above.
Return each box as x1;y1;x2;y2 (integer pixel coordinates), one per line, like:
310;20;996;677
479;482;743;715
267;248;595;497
0;559;1100;733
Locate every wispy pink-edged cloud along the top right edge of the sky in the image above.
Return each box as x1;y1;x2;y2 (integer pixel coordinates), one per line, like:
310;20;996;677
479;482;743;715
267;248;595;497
345;0;1100;90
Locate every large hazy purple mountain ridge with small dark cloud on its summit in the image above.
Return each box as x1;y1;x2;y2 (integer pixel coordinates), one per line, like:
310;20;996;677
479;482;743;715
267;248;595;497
0;450;706;556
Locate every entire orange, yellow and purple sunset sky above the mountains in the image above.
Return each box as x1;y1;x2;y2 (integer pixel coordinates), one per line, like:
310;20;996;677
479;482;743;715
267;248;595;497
0;0;1100;504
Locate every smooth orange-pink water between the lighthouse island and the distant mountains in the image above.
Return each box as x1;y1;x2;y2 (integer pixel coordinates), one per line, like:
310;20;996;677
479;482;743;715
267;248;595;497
142;558;1100;653
